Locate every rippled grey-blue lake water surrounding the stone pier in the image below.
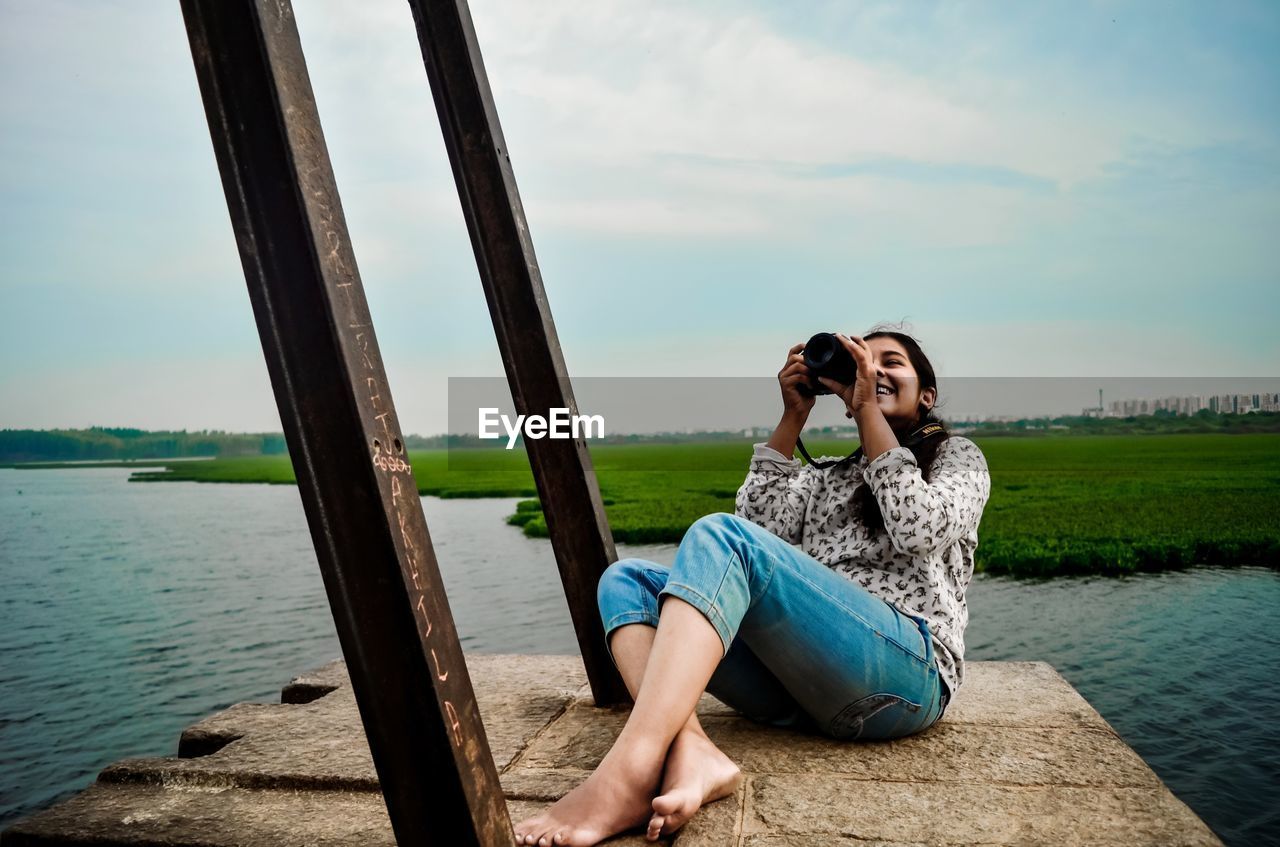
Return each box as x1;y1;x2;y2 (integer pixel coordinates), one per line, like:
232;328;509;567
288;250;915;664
0;468;1280;844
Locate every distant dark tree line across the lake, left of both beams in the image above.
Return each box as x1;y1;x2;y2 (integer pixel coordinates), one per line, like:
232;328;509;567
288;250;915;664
0;426;285;464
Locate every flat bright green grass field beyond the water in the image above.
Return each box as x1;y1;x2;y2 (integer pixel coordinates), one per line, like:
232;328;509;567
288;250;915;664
122;434;1280;576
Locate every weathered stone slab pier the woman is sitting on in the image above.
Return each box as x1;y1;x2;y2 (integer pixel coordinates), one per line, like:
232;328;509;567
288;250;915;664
0;655;1221;847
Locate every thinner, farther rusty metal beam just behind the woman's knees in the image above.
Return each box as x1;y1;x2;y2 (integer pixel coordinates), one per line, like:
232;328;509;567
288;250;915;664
410;0;631;705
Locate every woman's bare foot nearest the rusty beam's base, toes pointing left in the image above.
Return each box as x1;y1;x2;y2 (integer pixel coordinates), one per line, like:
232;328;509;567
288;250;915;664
515;748;662;847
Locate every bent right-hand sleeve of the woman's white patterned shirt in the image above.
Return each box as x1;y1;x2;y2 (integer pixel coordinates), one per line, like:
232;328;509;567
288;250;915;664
865;436;991;555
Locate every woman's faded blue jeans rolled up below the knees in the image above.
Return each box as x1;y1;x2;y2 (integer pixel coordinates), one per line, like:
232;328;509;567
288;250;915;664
598;514;947;740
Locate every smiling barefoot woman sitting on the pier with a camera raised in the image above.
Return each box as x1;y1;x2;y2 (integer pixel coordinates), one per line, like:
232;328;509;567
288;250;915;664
516;330;991;847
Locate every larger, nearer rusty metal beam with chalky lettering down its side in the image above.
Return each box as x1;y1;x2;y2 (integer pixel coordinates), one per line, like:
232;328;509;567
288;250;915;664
182;0;512;847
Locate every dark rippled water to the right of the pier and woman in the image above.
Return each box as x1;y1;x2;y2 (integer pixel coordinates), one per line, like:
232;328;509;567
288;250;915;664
966;567;1280;844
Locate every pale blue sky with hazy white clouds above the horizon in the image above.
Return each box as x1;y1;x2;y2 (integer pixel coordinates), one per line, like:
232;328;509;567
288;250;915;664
0;0;1280;434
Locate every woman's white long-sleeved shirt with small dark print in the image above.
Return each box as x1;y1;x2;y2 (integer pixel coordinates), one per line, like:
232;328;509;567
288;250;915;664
736;435;991;697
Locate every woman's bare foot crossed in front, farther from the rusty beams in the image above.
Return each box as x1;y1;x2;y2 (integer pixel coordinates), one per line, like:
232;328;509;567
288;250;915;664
645;729;742;841
